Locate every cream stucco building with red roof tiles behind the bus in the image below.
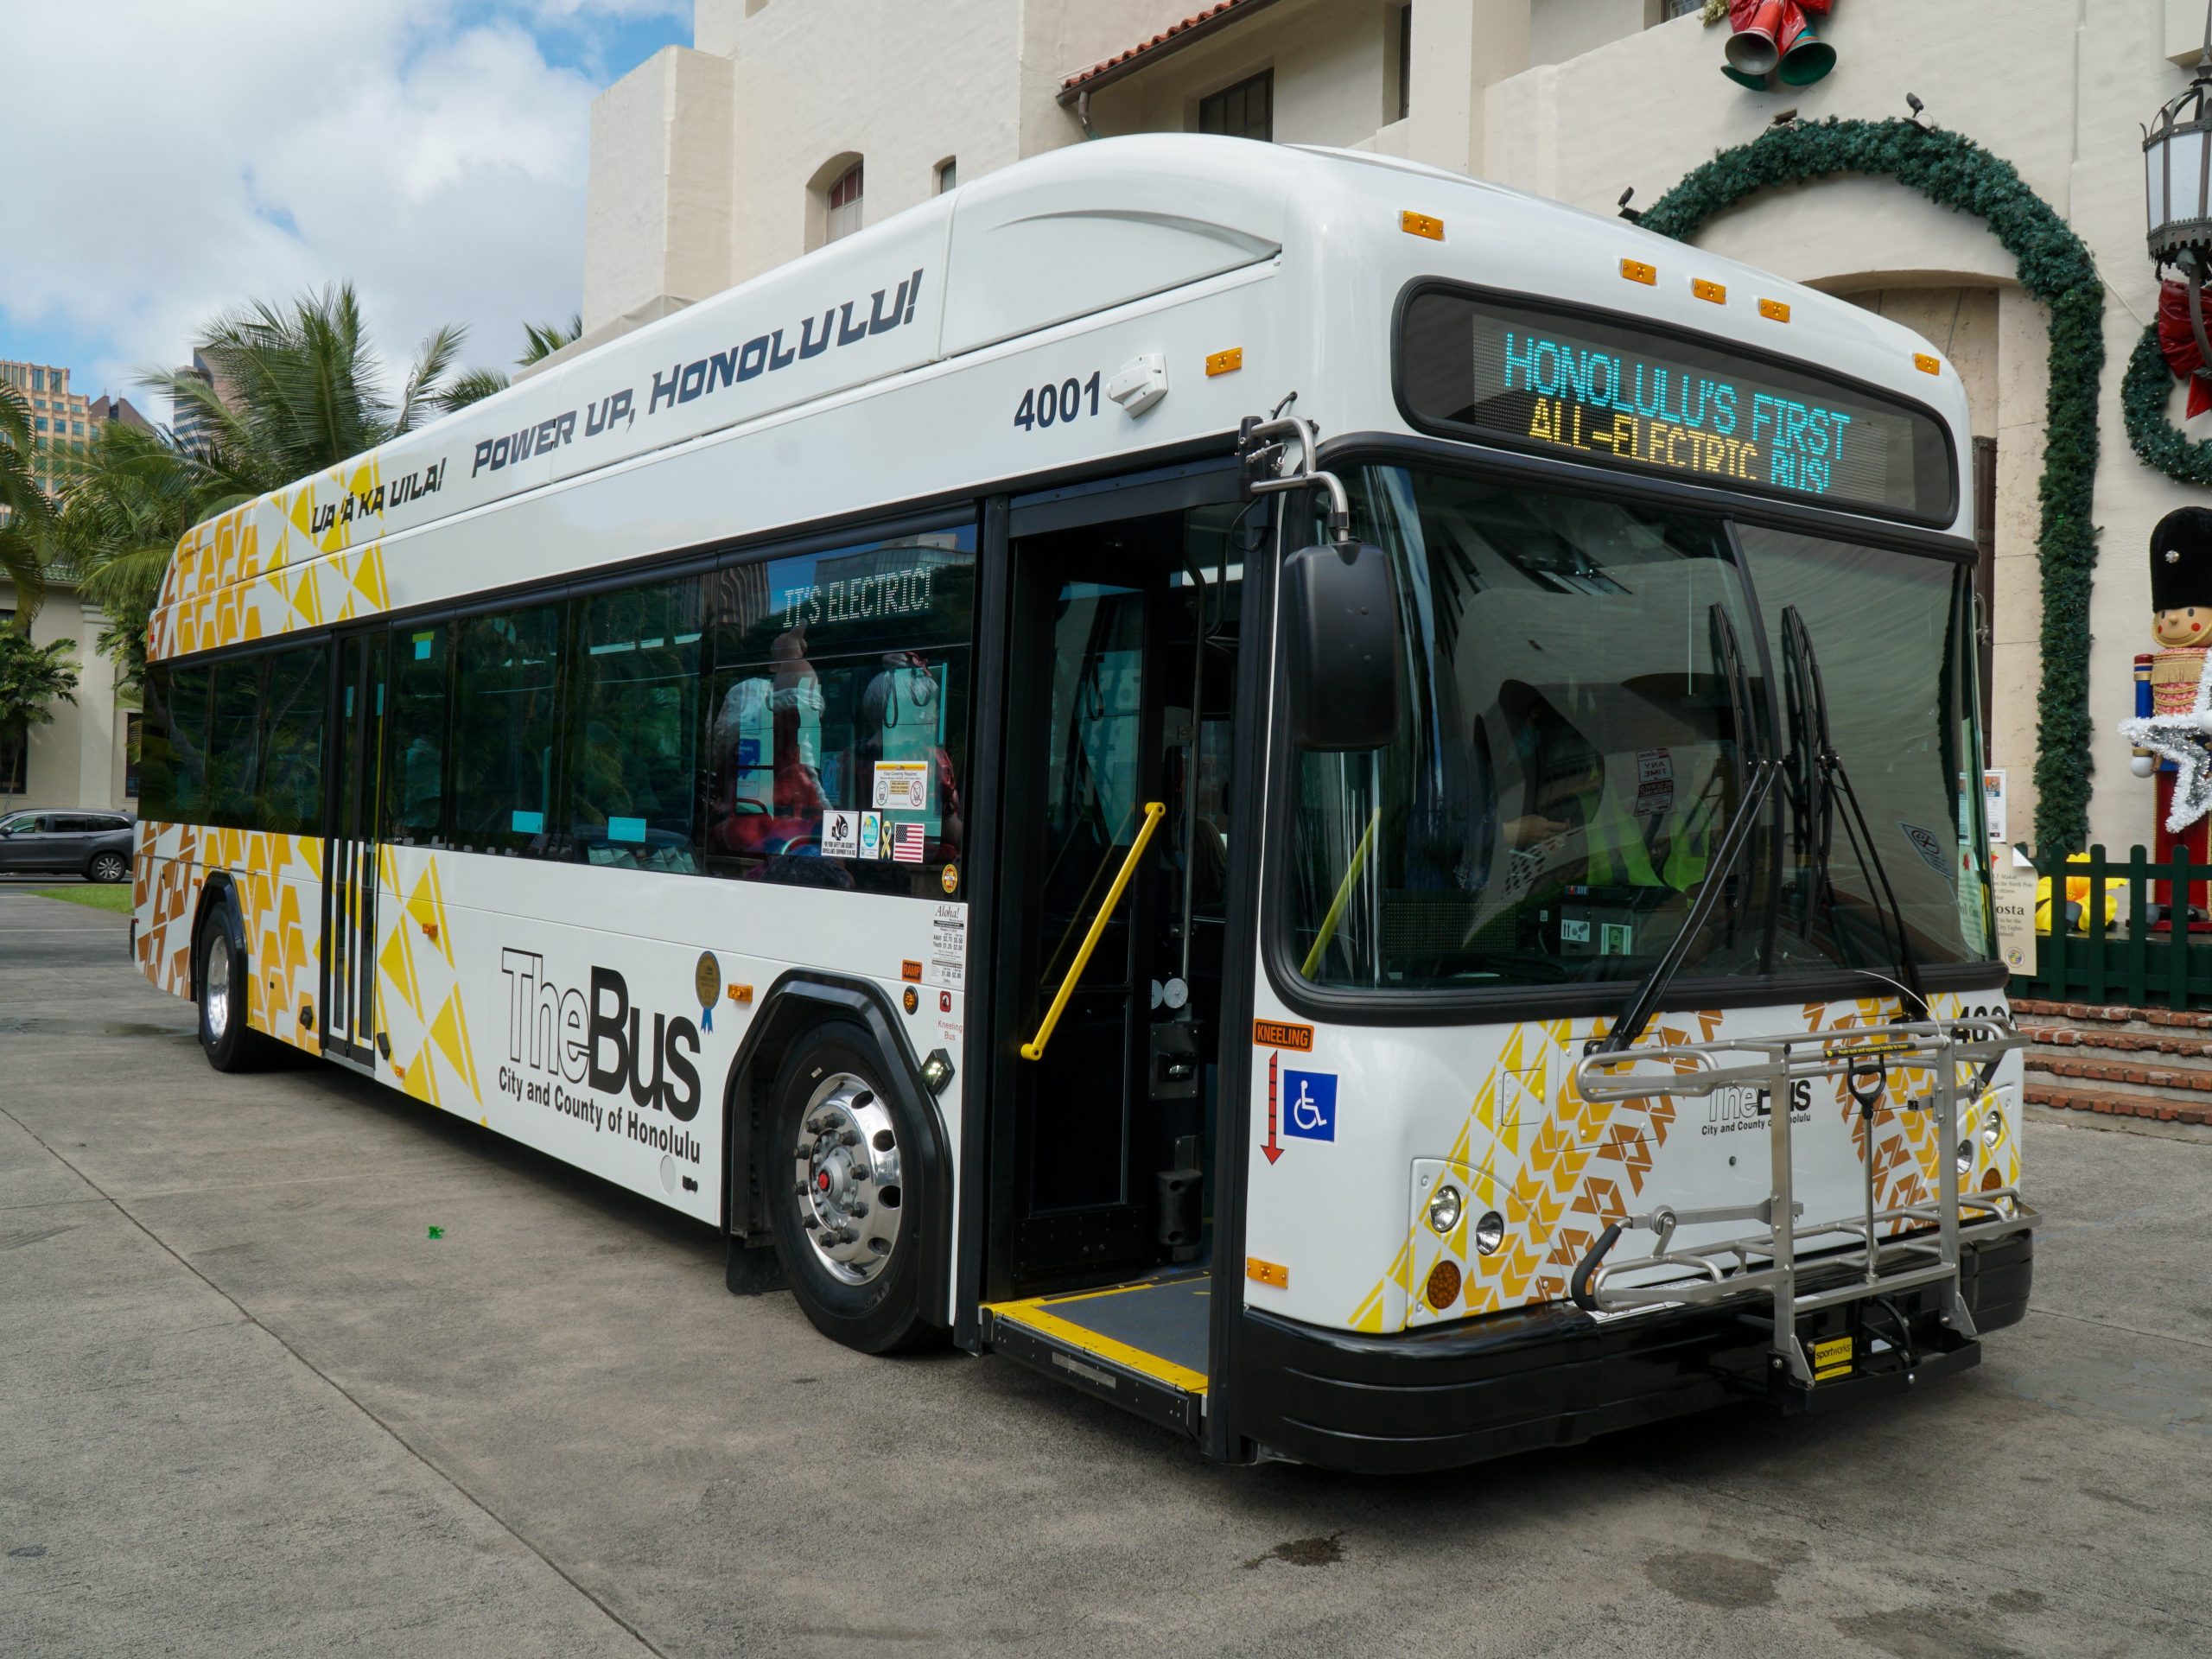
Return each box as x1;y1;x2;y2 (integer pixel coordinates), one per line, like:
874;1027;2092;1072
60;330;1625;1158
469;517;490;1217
584;0;2212;847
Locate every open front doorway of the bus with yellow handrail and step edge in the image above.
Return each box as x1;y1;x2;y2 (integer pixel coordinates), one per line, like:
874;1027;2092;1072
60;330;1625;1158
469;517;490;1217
982;474;1261;1433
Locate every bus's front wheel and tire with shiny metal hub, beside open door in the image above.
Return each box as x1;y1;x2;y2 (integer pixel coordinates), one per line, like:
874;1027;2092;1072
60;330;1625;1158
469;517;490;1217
759;1020;943;1354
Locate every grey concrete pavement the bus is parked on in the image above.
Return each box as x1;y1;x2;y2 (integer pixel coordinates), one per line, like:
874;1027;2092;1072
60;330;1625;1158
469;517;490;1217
0;892;2212;1659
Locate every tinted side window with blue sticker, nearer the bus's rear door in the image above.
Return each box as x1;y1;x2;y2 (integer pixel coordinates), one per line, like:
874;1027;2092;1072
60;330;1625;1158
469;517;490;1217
451;604;562;852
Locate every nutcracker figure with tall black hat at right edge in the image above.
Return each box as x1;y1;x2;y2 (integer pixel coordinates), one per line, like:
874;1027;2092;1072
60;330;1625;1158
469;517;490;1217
2121;506;2212;929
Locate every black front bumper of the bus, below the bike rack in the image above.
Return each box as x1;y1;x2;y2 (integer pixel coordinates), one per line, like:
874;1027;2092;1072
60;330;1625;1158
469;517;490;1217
1239;1232;2035;1473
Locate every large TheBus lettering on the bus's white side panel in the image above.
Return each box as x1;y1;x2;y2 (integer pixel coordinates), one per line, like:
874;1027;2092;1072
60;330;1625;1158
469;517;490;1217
500;949;699;1123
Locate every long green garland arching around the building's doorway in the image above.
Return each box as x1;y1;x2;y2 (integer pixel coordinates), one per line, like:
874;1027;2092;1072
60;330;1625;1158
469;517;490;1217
1643;119;2096;847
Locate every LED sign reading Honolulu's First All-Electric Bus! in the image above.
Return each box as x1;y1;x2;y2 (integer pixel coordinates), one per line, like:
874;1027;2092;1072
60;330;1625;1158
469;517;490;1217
1398;292;1951;520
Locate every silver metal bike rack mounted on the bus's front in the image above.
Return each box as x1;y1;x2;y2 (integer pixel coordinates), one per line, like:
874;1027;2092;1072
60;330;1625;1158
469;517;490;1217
1571;1018;2039;1389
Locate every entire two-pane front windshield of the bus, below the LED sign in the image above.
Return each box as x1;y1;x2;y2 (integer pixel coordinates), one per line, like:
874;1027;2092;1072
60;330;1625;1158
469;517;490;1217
1283;467;1991;991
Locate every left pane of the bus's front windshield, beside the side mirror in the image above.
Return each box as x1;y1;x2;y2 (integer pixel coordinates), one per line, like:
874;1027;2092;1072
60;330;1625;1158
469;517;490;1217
1289;467;1763;988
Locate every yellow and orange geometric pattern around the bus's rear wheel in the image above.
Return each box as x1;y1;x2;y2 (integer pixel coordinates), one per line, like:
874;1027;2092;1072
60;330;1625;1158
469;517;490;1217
133;823;323;1053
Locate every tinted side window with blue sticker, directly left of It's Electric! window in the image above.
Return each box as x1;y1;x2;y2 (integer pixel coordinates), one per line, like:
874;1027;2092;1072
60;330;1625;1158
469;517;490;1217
569;577;702;872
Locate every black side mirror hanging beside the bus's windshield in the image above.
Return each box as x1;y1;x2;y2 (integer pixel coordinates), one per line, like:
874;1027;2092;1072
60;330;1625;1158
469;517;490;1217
1283;542;1398;754
